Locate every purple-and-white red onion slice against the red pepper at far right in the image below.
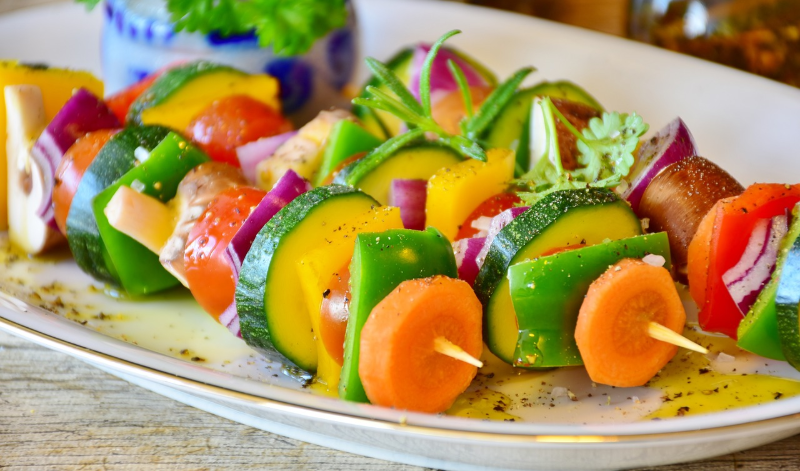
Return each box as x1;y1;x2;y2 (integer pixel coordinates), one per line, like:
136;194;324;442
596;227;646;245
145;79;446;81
722;216;789;315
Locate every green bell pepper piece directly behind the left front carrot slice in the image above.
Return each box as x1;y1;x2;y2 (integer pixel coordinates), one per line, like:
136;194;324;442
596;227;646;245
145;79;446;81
339;227;458;402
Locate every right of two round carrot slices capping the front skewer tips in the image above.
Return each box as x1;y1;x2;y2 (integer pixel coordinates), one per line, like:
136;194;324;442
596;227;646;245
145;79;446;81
575;259;686;387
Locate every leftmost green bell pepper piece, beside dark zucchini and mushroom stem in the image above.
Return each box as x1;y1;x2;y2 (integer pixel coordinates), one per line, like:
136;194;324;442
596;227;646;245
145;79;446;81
92;132;210;296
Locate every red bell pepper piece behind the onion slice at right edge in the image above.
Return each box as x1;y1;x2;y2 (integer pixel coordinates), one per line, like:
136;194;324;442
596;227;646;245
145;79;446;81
698;183;800;339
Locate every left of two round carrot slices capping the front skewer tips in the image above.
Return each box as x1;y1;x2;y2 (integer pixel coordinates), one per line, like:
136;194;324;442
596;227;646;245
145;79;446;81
358;276;483;413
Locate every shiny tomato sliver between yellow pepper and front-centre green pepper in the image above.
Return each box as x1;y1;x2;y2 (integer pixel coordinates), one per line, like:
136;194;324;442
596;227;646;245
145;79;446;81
319;264;352;365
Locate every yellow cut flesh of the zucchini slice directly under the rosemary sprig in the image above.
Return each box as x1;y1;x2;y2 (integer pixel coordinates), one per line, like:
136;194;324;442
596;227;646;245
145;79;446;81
357;146;461;205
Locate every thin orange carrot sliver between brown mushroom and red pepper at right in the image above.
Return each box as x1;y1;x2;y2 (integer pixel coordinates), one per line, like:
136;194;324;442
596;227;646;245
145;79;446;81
686;197;735;307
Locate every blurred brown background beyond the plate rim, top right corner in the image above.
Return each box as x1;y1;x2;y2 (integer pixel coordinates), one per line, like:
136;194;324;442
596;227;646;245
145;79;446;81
450;0;800;87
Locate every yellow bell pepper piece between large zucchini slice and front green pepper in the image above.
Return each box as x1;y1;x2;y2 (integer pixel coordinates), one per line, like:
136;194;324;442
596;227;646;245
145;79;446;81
297;207;403;397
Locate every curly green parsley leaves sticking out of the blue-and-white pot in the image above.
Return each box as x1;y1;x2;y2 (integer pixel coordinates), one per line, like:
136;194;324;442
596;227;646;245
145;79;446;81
76;0;347;55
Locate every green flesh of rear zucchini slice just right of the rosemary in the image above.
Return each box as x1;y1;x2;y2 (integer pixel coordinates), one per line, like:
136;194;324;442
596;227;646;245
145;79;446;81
481;80;603;176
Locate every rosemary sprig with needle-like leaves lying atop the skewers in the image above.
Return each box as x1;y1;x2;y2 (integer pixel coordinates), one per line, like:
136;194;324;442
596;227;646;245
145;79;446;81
353;30;534;162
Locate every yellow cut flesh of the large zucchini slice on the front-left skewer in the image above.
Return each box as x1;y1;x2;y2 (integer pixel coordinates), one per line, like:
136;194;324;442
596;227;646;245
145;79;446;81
265;193;375;371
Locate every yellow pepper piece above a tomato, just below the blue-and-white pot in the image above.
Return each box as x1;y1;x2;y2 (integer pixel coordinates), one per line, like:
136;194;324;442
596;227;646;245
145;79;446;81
142;71;281;132
